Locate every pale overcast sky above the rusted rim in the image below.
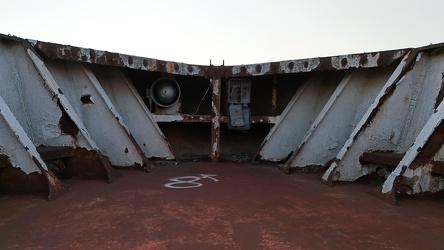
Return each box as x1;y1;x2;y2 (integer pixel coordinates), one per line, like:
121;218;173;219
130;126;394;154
0;0;444;65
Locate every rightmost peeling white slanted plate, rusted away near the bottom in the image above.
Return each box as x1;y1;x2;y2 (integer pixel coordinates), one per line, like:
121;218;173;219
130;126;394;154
323;48;444;203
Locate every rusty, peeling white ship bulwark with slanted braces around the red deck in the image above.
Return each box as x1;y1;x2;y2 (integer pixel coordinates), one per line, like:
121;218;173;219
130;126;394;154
0;35;444;203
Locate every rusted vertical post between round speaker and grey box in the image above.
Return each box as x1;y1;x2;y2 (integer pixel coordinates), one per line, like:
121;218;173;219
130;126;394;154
210;78;221;162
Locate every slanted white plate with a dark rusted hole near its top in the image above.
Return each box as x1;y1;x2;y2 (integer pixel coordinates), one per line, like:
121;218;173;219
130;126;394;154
46;61;151;167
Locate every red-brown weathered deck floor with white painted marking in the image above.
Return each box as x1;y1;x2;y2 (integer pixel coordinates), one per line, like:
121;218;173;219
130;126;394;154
0;162;444;249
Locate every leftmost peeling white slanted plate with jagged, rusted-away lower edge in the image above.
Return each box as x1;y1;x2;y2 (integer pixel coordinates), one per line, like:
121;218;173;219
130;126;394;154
0;43;74;200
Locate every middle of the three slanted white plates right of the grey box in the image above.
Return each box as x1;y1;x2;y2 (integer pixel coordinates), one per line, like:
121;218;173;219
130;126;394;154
283;67;393;172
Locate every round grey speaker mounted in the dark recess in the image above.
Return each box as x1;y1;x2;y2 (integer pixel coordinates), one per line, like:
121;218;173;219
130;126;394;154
151;78;180;108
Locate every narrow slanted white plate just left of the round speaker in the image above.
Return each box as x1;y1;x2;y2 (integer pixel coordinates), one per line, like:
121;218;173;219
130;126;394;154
92;67;176;160
